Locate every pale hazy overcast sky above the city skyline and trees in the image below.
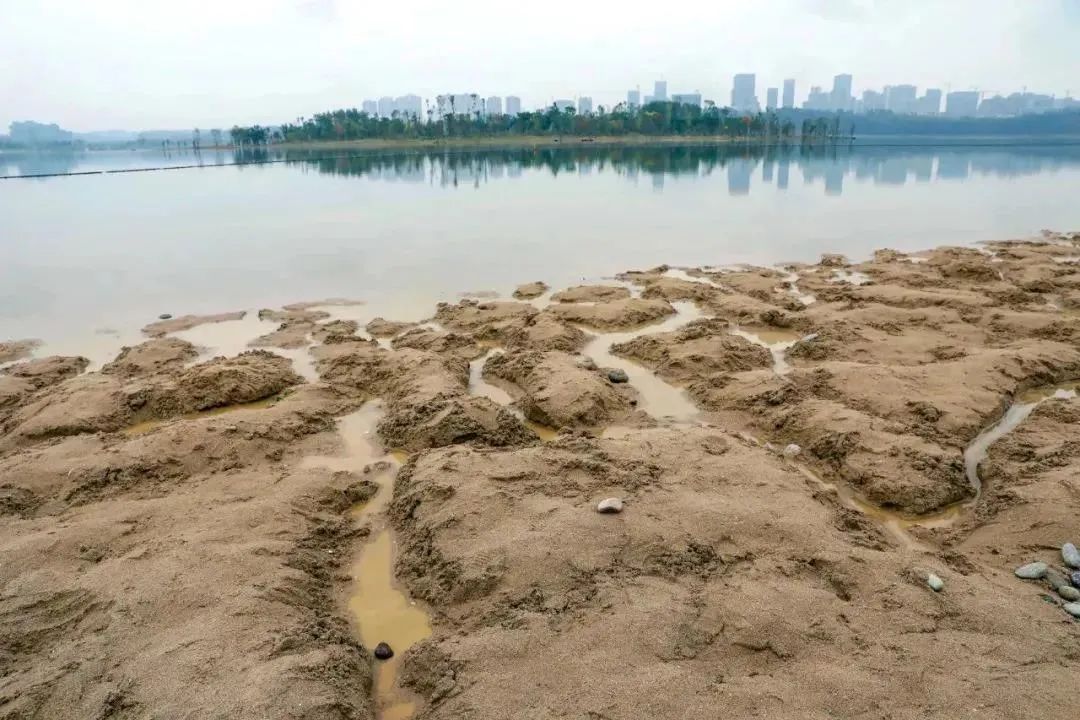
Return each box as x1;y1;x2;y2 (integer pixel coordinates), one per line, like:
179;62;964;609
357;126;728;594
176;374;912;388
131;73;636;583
0;0;1080;132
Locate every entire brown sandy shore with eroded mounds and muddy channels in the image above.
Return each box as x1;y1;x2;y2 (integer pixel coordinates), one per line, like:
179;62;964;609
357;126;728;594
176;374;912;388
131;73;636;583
0;233;1080;720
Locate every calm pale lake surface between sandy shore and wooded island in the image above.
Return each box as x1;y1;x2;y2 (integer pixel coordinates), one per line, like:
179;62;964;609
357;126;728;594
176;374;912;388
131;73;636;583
0;141;1080;352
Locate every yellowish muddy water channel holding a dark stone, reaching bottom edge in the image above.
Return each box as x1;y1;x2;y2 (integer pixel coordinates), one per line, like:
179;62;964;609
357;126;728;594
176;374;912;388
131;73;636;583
301;400;431;720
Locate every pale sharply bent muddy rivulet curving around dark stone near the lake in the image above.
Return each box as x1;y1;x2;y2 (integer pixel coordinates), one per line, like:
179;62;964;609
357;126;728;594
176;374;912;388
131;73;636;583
581;302;704;422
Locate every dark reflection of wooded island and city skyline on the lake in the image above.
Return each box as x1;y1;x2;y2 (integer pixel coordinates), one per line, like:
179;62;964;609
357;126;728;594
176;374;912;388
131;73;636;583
260;145;1080;196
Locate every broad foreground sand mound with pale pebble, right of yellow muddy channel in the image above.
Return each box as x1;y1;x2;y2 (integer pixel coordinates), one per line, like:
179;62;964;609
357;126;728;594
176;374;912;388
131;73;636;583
392;429;1072;718
